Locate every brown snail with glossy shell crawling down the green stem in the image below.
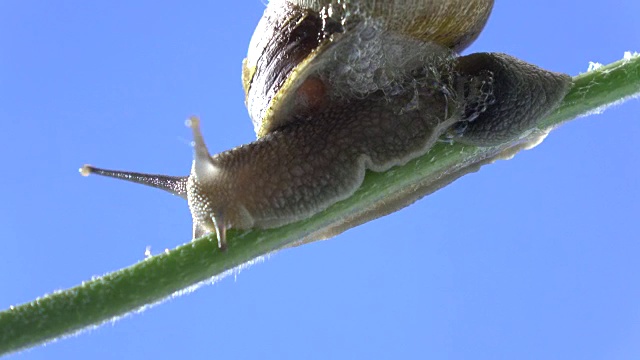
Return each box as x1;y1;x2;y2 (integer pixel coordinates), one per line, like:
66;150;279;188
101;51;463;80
80;0;571;249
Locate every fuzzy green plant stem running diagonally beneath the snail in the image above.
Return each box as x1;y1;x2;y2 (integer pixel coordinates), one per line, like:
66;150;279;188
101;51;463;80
0;56;640;355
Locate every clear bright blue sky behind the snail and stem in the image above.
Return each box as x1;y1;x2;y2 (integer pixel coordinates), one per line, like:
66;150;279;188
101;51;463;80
0;0;640;360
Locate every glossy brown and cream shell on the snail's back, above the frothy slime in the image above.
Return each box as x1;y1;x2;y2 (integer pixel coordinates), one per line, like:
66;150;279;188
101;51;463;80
242;0;493;138
